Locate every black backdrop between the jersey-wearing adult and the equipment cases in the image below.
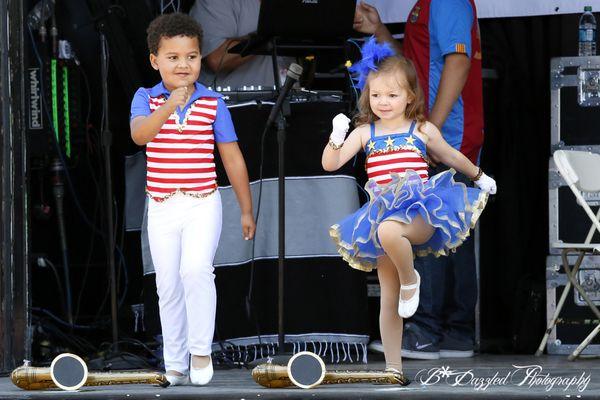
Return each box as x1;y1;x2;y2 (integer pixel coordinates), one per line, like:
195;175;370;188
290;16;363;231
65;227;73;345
480;15;578;353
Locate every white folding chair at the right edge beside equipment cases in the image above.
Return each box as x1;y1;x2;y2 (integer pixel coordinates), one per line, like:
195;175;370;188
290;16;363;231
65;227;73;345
536;150;600;361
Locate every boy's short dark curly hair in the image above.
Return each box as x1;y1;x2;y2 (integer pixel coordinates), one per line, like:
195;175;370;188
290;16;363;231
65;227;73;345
146;13;203;54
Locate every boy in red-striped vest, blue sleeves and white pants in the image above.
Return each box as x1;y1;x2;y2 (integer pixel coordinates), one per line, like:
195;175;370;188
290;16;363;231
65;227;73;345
131;13;255;385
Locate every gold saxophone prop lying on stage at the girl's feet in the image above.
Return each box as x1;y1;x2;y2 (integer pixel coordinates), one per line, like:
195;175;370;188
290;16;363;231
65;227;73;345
252;351;410;389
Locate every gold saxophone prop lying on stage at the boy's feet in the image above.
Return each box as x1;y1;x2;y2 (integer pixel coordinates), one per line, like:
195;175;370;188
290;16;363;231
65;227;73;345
10;353;169;390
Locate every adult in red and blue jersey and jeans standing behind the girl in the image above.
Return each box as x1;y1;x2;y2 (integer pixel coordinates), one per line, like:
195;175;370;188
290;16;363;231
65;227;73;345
354;0;483;359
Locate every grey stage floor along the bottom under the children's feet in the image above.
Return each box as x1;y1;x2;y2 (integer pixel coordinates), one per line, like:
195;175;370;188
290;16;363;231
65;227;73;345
0;354;600;400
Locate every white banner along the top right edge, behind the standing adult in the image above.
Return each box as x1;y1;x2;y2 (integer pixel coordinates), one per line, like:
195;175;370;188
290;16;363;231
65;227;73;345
366;0;600;23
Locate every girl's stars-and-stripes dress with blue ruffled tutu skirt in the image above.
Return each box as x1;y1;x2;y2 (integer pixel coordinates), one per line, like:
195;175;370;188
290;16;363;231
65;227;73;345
329;121;487;271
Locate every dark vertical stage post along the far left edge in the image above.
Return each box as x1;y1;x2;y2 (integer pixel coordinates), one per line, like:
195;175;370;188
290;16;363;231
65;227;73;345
0;0;31;372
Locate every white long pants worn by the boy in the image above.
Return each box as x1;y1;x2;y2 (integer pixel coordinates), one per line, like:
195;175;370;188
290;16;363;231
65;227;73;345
148;191;222;373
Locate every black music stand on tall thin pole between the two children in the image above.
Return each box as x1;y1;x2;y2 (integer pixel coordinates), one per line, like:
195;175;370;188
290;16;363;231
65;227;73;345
229;0;355;354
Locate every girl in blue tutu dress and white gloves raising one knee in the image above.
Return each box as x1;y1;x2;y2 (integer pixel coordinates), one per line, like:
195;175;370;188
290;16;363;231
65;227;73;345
322;38;496;374
